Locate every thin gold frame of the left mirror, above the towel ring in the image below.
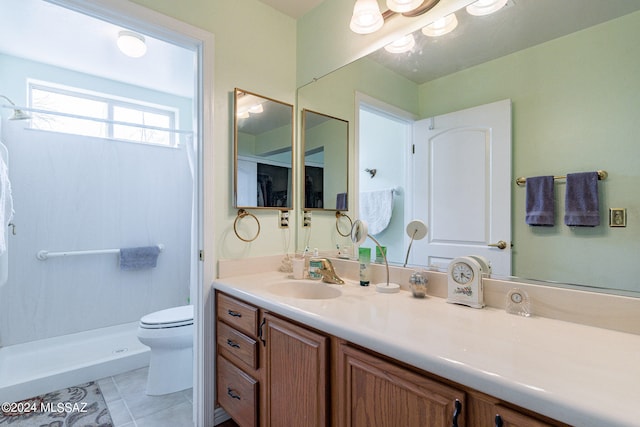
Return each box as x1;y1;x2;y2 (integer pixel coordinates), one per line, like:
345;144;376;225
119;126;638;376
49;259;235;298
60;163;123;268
232;88;296;211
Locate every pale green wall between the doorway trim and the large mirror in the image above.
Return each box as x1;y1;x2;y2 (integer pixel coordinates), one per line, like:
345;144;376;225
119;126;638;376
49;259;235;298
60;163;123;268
132;0;296;263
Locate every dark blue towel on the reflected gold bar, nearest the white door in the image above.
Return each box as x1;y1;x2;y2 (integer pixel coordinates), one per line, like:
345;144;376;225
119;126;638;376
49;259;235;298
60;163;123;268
525;176;556;226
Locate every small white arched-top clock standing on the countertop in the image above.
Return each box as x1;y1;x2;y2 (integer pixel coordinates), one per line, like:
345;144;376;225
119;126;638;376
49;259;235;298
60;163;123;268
447;256;491;308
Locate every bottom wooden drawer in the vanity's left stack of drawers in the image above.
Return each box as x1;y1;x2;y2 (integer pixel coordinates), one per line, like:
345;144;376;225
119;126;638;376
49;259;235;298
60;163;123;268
217;357;258;427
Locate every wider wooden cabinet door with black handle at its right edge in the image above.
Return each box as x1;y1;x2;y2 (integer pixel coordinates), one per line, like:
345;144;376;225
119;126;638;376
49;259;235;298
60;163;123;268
339;345;465;427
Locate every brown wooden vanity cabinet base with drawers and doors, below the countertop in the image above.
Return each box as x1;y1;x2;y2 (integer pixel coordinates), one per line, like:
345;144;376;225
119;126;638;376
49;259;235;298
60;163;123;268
216;292;568;427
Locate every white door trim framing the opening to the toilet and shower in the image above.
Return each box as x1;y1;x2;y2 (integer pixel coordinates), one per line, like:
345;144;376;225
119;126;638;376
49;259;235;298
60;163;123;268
46;0;216;427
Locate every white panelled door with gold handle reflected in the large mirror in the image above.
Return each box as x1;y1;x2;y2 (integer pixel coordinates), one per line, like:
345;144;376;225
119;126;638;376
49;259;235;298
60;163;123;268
410;99;511;275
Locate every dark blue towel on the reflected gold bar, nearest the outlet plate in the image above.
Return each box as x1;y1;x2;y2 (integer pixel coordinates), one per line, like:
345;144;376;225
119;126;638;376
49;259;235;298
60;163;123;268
564;172;600;227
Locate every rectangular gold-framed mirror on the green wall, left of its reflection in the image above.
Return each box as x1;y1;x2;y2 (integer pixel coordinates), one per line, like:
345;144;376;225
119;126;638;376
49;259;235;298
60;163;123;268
233;88;294;209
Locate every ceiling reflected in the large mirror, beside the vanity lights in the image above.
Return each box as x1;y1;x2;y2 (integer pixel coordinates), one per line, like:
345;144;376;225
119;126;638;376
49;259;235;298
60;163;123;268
370;0;640;84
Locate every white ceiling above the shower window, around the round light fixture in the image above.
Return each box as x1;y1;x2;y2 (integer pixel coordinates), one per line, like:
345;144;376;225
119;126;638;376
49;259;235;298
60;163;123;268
0;0;195;98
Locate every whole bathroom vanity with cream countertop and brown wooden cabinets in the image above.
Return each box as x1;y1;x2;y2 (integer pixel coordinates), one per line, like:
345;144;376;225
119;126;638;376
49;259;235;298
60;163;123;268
213;272;640;427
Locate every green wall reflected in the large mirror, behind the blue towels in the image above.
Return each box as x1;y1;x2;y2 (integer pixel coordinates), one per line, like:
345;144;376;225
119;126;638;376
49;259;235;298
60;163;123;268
420;12;640;291
